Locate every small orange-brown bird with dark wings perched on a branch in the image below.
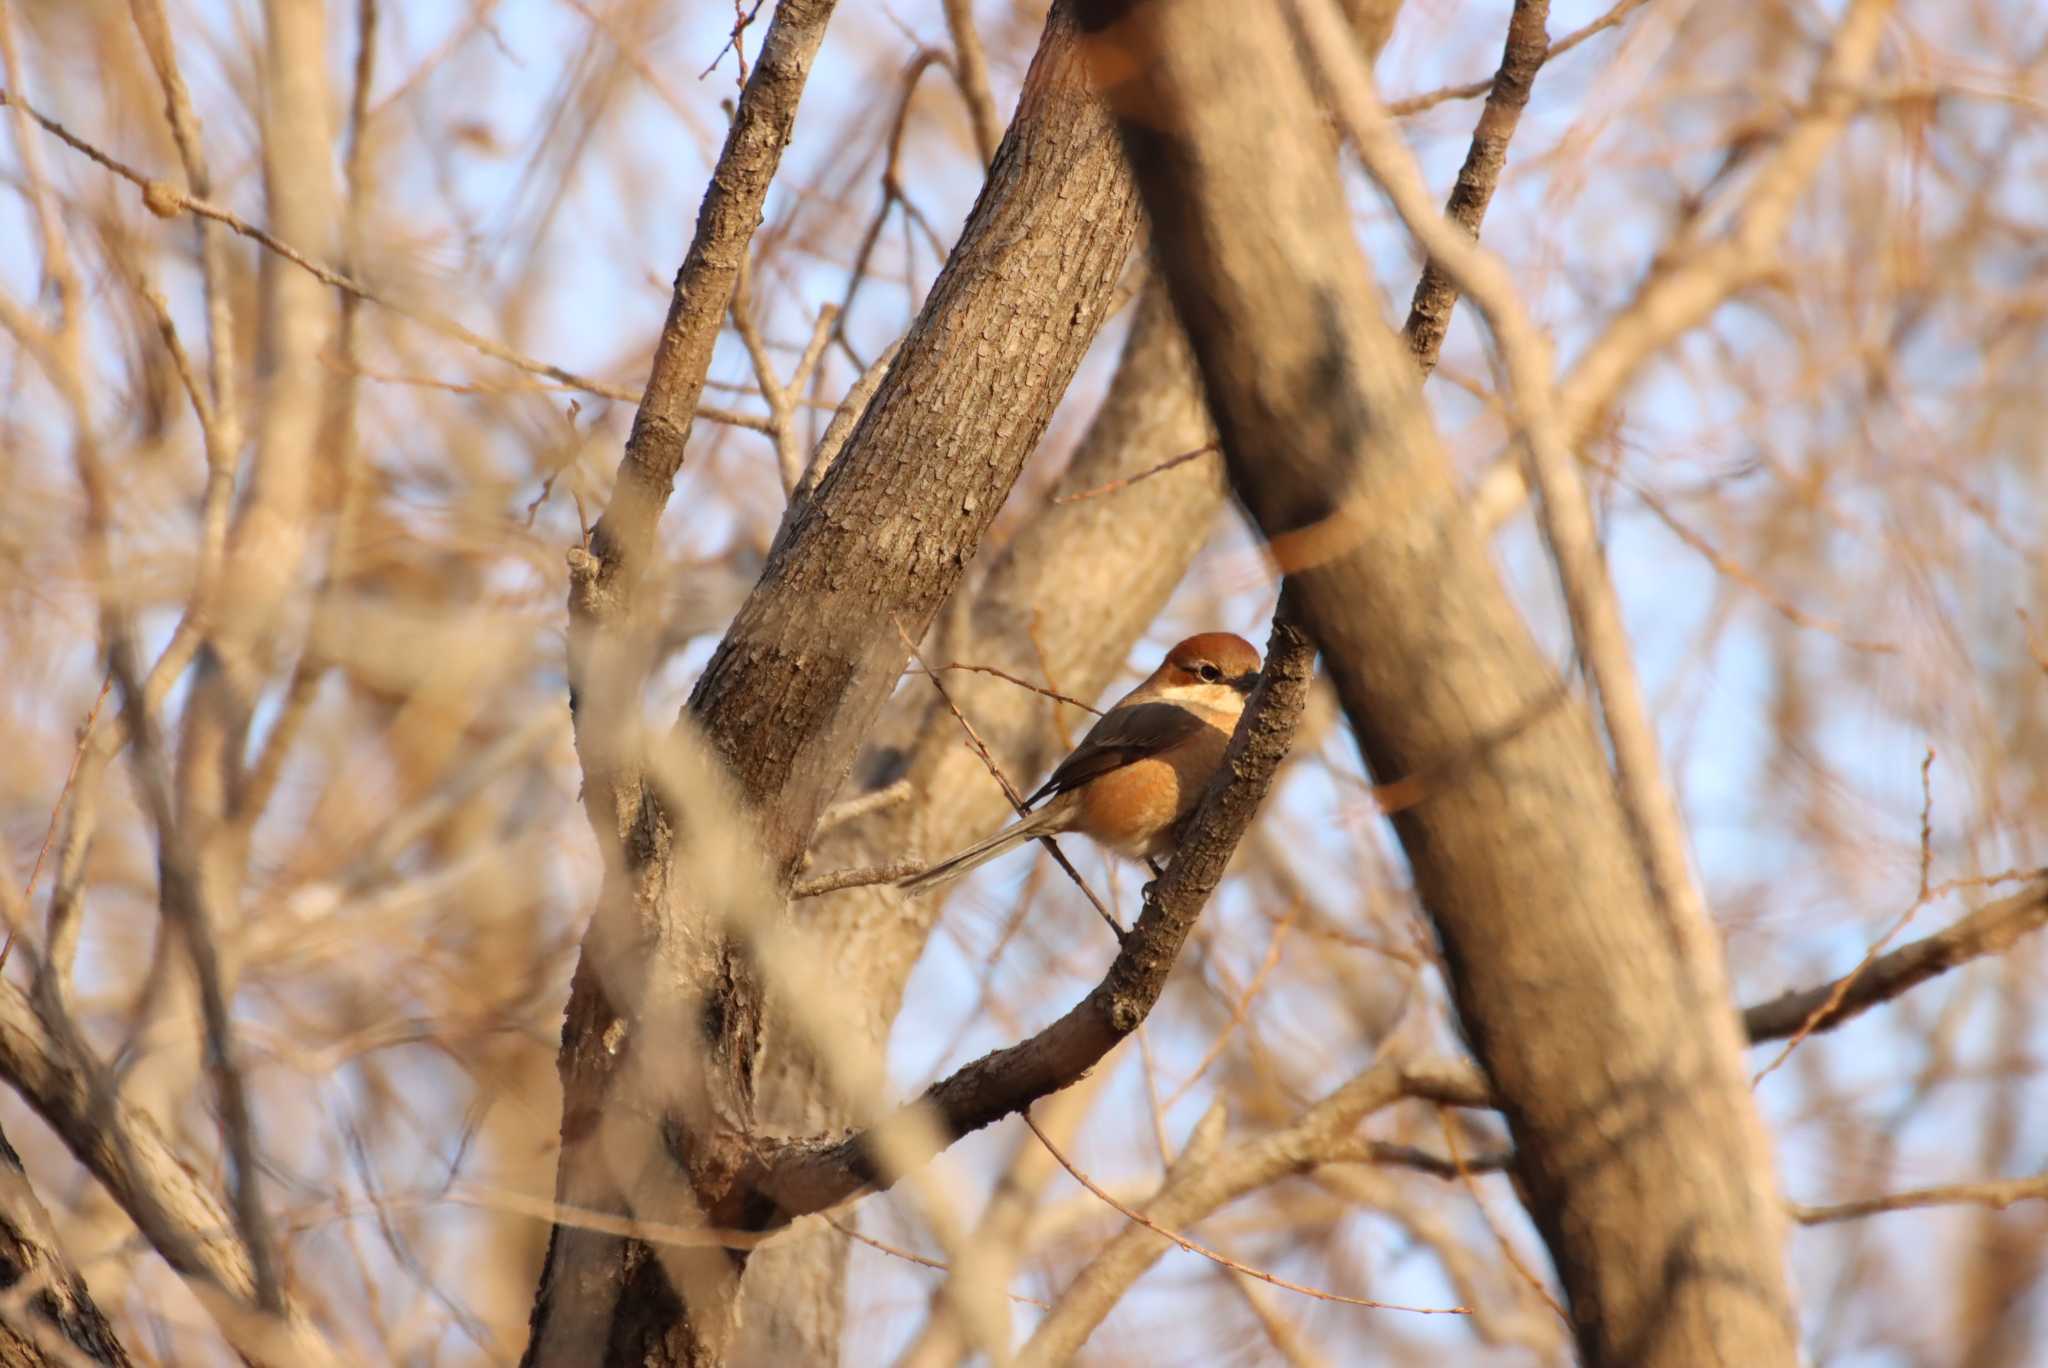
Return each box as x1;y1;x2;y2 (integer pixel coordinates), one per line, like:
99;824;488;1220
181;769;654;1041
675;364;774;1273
897;631;1260;893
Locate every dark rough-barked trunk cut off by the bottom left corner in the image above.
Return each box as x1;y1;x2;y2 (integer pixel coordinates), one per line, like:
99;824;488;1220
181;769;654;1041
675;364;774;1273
0;1135;129;1368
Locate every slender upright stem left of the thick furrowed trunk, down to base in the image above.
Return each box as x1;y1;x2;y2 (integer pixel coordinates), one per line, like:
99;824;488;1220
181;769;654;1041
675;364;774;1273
526;0;834;1364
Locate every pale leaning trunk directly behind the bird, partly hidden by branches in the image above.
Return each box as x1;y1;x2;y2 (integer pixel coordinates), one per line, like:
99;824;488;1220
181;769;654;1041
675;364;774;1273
741;285;1225;1362
